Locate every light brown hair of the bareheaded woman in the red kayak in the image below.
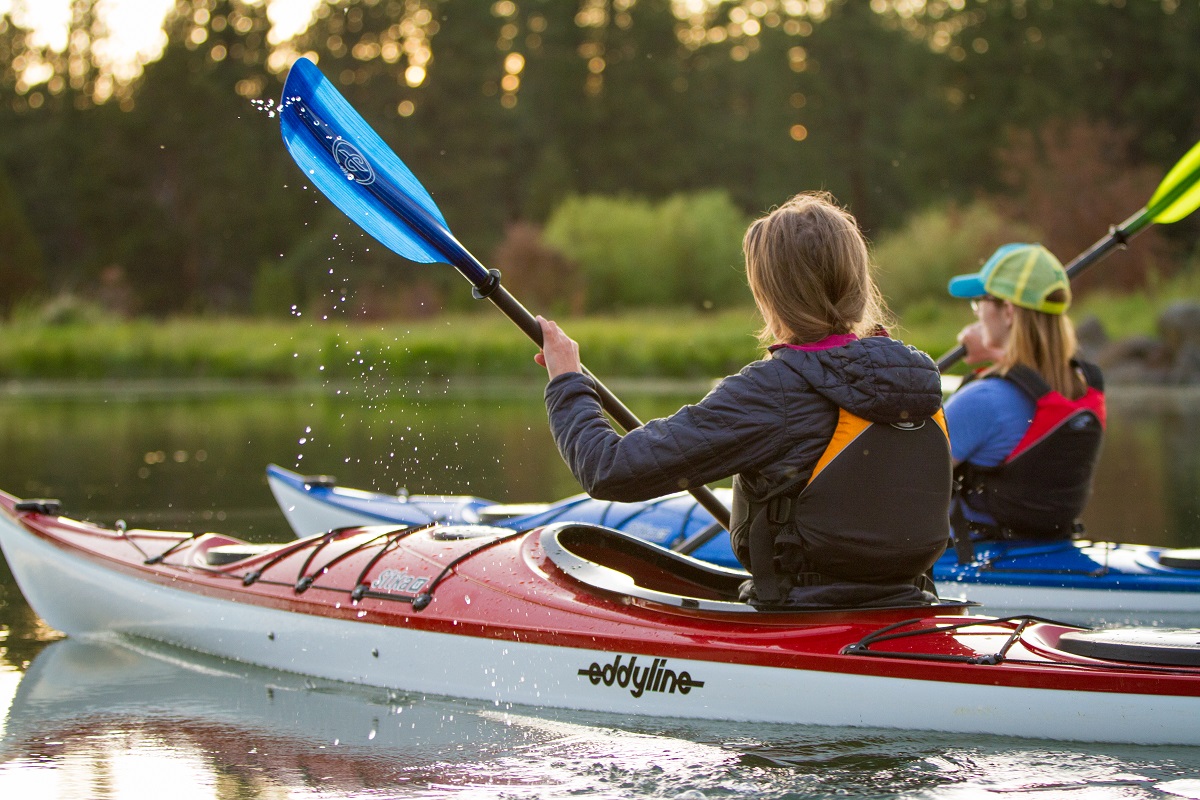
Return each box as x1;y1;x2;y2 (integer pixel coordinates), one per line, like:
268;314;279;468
742;192;887;345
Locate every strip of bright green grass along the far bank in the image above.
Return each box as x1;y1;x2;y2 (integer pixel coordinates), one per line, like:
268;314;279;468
0;282;1196;385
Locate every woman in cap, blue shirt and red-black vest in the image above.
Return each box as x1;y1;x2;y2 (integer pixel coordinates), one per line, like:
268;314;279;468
946;243;1105;561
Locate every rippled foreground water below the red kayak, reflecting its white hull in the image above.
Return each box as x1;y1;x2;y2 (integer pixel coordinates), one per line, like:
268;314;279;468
0;640;1200;800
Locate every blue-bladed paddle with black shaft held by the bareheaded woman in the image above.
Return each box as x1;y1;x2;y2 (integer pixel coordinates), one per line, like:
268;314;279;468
280;59;730;529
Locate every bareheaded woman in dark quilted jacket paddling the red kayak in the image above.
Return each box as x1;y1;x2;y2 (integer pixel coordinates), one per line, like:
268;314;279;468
536;193;952;608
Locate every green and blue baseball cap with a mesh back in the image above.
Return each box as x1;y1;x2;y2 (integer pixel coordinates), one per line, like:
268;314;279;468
948;245;1070;314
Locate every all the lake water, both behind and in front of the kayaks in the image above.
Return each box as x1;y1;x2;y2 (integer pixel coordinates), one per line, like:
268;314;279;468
0;385;1200;800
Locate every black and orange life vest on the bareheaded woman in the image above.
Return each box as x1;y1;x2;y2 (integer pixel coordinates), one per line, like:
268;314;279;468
730;409;953;604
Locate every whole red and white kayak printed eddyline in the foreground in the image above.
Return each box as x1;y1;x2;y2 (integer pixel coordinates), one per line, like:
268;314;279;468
0;493;1200;745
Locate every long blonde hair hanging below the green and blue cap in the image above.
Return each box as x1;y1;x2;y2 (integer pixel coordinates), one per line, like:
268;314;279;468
994;296;1087;399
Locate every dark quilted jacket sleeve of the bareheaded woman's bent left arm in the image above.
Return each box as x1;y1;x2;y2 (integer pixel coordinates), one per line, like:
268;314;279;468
546;365;791;503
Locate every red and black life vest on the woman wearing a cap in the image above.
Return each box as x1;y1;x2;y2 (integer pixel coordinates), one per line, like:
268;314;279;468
955;361;1105;540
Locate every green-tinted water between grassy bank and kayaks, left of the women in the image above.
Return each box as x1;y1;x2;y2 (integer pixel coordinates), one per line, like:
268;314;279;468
0;387;578;540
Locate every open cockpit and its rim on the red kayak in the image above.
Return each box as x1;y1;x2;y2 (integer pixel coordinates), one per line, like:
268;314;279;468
538;523;977;615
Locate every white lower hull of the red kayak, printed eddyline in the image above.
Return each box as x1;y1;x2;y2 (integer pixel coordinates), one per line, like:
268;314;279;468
0;503;1200;744
